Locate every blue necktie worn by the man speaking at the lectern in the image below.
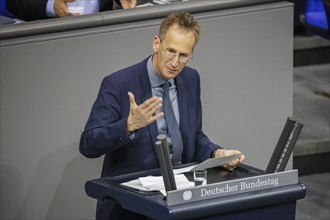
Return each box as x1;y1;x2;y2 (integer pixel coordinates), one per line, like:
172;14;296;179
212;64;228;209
163;81;183;165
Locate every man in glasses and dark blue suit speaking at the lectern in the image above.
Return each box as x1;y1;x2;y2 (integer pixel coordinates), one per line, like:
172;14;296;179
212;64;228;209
80;12;244;220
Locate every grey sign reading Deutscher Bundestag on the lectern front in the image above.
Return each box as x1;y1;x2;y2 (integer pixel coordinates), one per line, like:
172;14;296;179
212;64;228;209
166;170;298;205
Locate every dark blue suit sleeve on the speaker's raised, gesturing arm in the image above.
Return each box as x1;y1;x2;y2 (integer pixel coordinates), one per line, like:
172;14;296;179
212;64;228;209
80;75;130;158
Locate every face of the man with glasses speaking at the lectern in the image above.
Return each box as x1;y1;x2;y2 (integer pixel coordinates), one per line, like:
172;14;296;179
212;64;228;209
153;25;195;79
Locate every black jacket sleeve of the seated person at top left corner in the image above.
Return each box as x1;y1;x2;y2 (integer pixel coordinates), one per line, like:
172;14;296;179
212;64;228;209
6;0;48;21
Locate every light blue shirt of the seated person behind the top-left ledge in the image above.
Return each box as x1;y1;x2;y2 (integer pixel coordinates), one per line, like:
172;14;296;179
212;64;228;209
46;0;100;17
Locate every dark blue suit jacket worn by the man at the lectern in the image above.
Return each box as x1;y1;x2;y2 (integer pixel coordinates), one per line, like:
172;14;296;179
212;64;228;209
80;56;219;176
